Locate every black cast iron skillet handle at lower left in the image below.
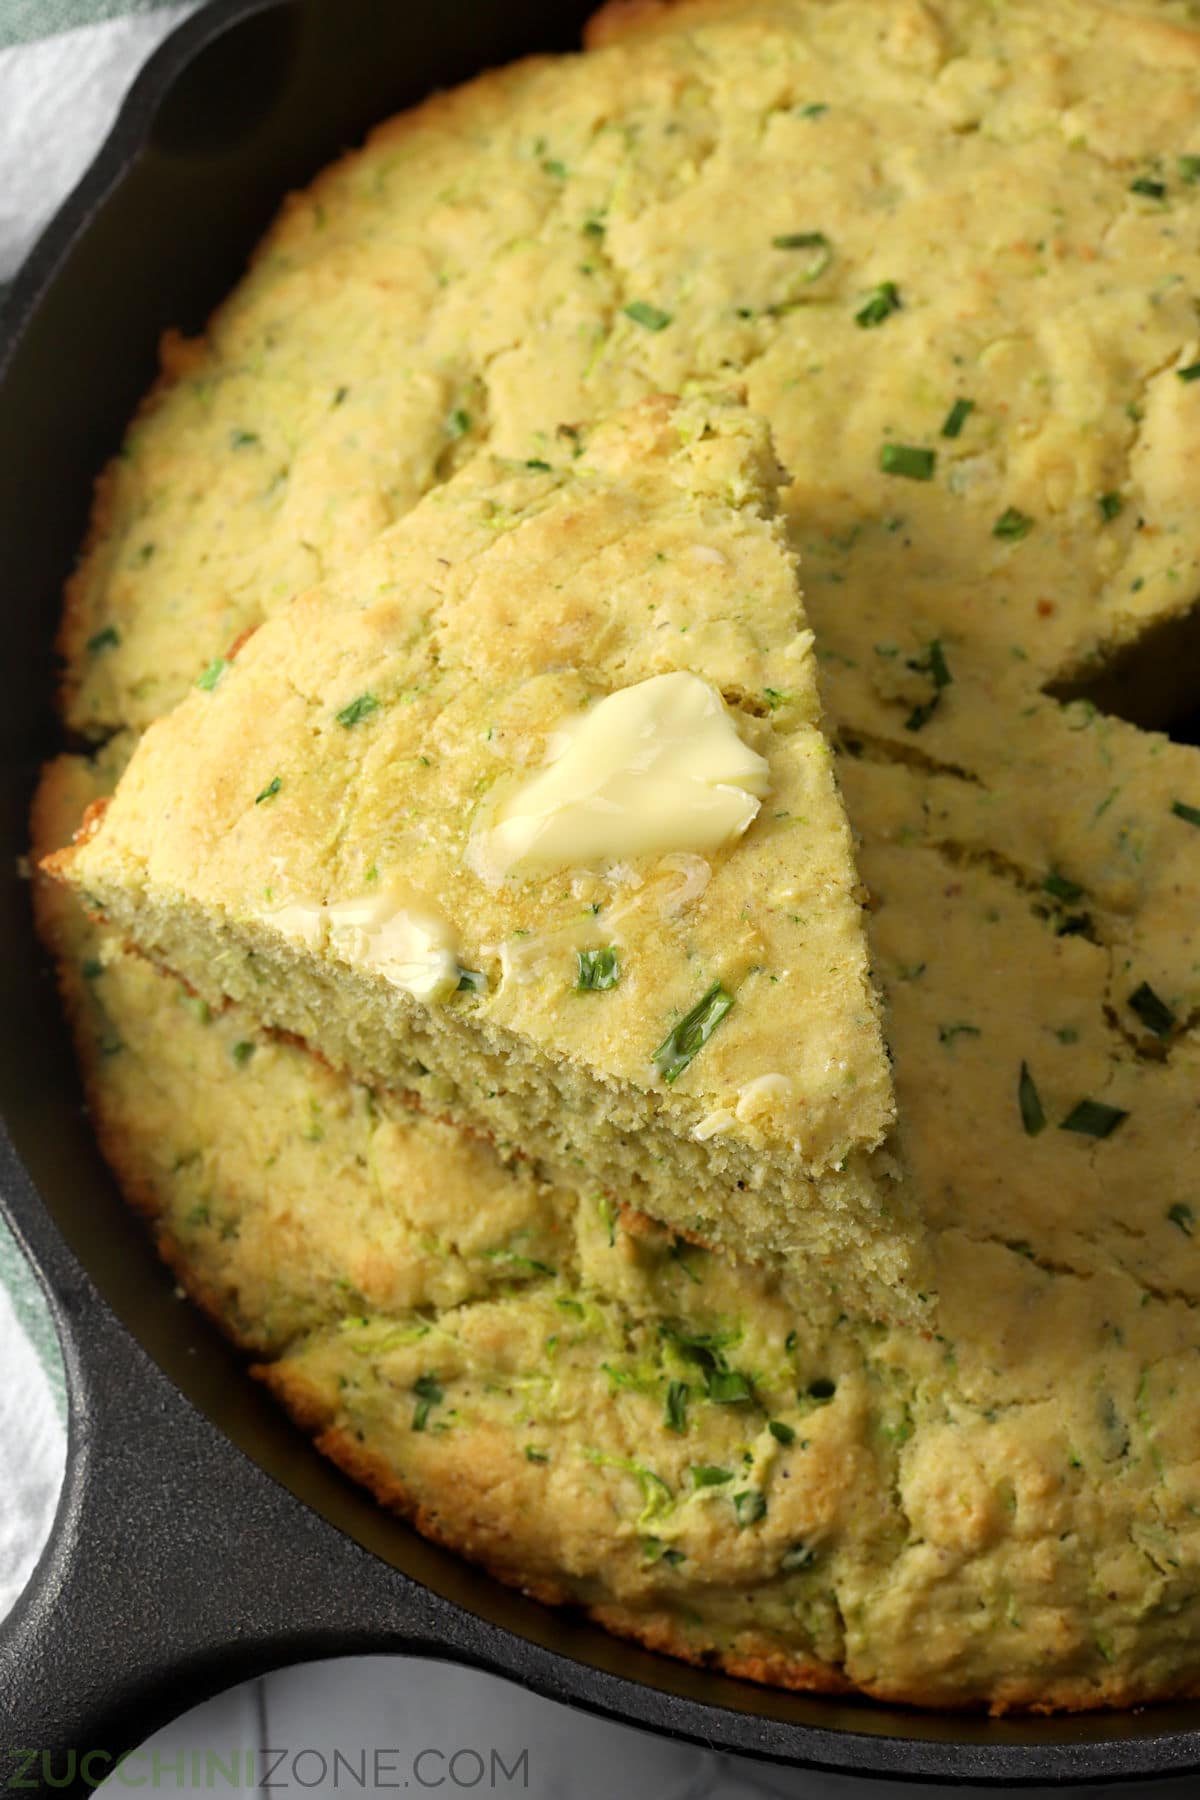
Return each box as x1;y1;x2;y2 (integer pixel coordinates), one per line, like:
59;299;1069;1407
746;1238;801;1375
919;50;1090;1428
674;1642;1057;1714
0;1180;478;1793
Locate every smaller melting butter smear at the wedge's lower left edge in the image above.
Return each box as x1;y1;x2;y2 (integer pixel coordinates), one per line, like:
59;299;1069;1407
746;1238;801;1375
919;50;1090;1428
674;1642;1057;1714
263;882;459;1001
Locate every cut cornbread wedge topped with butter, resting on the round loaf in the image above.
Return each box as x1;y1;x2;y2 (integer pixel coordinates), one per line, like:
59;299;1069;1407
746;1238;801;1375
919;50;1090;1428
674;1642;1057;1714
42;400;918;1310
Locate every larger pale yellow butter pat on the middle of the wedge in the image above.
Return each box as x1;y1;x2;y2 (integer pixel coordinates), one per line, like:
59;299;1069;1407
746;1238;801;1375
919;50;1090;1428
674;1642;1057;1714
468;671;770;886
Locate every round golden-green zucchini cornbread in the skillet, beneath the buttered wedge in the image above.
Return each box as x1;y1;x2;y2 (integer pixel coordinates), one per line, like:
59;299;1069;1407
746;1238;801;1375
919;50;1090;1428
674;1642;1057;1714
30;0;1200;1710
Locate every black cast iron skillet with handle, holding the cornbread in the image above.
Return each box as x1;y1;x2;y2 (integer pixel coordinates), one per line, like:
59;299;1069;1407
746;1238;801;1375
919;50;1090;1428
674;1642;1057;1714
0;0;1200;1787
